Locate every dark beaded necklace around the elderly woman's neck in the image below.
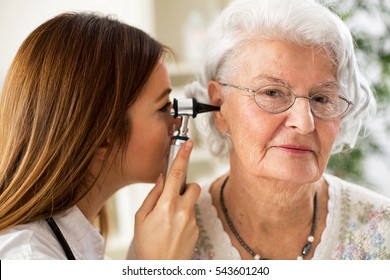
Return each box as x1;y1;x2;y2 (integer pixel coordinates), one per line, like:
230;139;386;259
219;176;317;260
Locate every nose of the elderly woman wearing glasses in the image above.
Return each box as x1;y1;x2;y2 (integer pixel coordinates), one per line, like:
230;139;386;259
286;98;315;134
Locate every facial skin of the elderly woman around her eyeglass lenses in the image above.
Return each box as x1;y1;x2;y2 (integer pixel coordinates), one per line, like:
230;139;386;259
214;41;340;183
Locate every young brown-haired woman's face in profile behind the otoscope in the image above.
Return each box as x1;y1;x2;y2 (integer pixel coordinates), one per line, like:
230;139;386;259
118;62;178;184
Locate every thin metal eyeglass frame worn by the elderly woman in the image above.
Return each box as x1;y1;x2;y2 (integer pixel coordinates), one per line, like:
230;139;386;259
217;81;354;120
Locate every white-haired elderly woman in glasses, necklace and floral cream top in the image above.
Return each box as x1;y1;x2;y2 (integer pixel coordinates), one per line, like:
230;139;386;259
188;0;390;259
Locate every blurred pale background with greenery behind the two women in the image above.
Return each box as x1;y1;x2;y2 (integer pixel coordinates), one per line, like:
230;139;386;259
0;0;390;259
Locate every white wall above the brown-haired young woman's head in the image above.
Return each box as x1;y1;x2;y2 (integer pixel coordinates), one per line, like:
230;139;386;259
0;0;154;88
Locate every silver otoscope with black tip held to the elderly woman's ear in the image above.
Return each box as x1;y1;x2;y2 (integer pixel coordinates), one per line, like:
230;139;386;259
166;98;219;194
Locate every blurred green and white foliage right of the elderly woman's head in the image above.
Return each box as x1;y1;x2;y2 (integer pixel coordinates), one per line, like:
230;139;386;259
328;0;390;187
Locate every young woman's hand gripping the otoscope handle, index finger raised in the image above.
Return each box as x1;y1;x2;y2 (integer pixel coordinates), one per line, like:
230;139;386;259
133;140;200;260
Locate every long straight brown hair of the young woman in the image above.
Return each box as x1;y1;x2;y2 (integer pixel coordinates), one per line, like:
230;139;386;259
0;13;166;233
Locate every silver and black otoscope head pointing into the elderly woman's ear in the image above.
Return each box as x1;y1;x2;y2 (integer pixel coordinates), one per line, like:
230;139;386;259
171;98;219;118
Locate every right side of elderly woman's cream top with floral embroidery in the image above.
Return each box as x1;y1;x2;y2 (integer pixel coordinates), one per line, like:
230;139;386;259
325;175;390;260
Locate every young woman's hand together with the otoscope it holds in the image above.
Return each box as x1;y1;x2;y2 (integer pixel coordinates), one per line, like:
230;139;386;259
134;98;219;260
